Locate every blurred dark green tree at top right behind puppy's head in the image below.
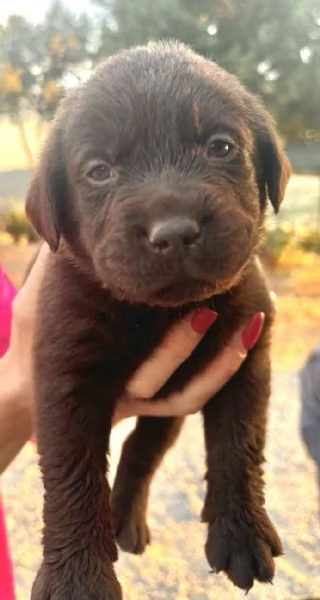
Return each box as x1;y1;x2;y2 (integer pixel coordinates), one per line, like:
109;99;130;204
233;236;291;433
93;0;320;139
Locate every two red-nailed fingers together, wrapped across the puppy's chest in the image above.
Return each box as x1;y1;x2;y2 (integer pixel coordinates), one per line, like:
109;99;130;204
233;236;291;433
113;308;264;424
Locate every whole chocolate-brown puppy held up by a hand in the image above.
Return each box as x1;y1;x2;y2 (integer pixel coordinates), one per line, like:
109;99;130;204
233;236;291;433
27;39;289;600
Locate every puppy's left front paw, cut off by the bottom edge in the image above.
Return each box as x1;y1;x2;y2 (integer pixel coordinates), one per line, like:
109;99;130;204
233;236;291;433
31;564;122;600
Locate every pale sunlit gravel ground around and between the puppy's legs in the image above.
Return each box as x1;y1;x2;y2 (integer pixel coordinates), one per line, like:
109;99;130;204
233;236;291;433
1;373;320;600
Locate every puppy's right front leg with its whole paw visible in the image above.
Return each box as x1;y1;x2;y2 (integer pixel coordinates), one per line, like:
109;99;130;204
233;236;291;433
203;334;282;590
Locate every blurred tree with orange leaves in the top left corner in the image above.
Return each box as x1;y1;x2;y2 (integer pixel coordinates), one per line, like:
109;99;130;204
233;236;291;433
0;2;91;164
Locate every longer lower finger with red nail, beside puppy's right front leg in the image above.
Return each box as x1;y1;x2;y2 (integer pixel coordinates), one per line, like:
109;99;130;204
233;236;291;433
115;313;264;422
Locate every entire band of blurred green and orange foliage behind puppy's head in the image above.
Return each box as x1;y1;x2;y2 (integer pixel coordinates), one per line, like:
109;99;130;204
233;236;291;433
0;0;320;141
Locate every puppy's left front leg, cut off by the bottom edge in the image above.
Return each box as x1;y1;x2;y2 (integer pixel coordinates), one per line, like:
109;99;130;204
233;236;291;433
31;299;122;600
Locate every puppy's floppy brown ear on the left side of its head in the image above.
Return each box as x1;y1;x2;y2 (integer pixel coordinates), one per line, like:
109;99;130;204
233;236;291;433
26;126;67;252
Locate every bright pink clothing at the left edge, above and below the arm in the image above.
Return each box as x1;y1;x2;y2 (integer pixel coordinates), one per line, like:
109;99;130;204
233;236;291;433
0;266;16;600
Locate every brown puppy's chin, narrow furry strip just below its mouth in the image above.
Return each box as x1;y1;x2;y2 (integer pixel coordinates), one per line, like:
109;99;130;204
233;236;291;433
103;269;243;308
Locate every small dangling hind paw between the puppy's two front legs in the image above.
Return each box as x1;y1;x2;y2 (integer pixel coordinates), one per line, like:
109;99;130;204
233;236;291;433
112;499;150;554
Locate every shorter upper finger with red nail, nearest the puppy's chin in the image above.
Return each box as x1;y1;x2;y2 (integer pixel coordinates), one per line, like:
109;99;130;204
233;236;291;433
127;308;218;398
